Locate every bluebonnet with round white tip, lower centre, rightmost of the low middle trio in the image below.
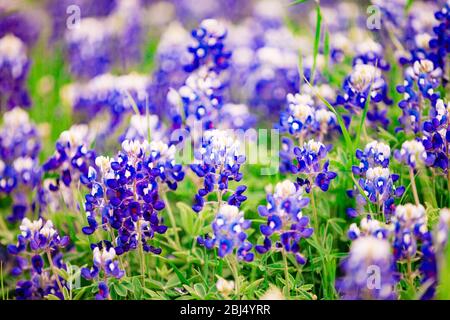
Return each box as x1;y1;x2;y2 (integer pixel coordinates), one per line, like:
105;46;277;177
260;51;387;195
255;180;313;264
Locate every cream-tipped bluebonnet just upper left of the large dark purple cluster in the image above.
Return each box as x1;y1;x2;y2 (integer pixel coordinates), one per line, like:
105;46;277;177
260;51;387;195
43;124;95;195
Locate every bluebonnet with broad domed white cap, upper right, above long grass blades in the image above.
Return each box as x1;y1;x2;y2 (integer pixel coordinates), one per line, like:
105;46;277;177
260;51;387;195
336;64;392;127
